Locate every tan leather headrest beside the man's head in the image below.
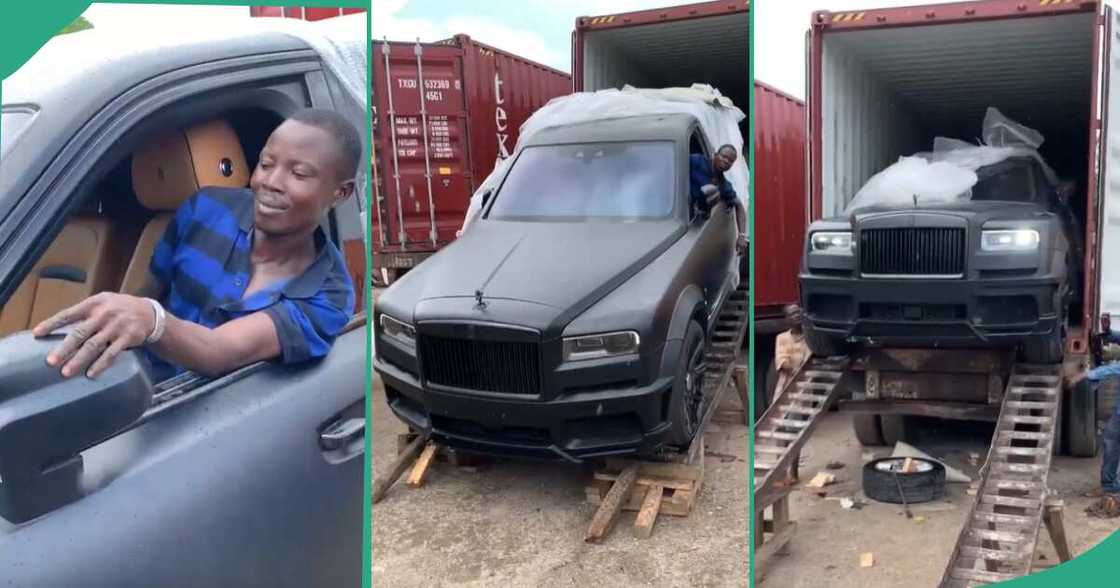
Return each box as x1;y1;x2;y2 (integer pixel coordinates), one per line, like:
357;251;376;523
132;120;249;211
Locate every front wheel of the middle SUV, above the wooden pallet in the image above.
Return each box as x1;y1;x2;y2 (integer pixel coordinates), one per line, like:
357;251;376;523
669;320;708;447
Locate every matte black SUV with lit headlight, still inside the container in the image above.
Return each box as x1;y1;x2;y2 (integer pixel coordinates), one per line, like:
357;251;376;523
800;157;1080;362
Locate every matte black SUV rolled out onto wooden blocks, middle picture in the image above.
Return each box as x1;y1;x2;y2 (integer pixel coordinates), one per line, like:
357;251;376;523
374;114;738;461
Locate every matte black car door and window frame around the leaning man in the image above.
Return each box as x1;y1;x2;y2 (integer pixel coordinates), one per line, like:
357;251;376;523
0;44;367;586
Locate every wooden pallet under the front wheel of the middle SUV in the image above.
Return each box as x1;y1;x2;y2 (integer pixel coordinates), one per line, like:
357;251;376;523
584;434;703;543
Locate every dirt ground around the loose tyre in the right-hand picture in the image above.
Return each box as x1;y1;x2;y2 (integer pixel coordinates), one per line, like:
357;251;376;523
758;412;1120;588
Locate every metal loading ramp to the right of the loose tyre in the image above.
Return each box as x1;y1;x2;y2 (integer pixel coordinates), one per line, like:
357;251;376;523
940;364;1067;588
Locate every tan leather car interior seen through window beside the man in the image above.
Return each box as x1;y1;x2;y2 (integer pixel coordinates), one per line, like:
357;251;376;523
0;108;282;347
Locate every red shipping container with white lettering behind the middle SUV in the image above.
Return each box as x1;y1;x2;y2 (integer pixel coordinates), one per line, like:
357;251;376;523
371;35;571;273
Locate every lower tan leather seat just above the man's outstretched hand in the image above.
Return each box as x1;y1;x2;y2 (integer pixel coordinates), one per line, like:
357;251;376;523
0;215;119;337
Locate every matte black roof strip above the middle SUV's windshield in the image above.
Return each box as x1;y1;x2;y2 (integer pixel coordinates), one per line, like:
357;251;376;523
526;113;697;146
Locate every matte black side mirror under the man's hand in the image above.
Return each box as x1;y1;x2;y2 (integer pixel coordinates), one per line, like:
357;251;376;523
0;332;152;524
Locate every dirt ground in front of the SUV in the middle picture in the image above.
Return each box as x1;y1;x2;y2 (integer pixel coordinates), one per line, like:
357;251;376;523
372;377;749;588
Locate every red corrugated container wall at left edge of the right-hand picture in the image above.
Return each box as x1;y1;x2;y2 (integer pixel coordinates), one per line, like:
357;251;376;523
752;82;809;318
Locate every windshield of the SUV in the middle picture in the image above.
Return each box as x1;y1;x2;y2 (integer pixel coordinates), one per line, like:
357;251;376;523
487;141;675;221
